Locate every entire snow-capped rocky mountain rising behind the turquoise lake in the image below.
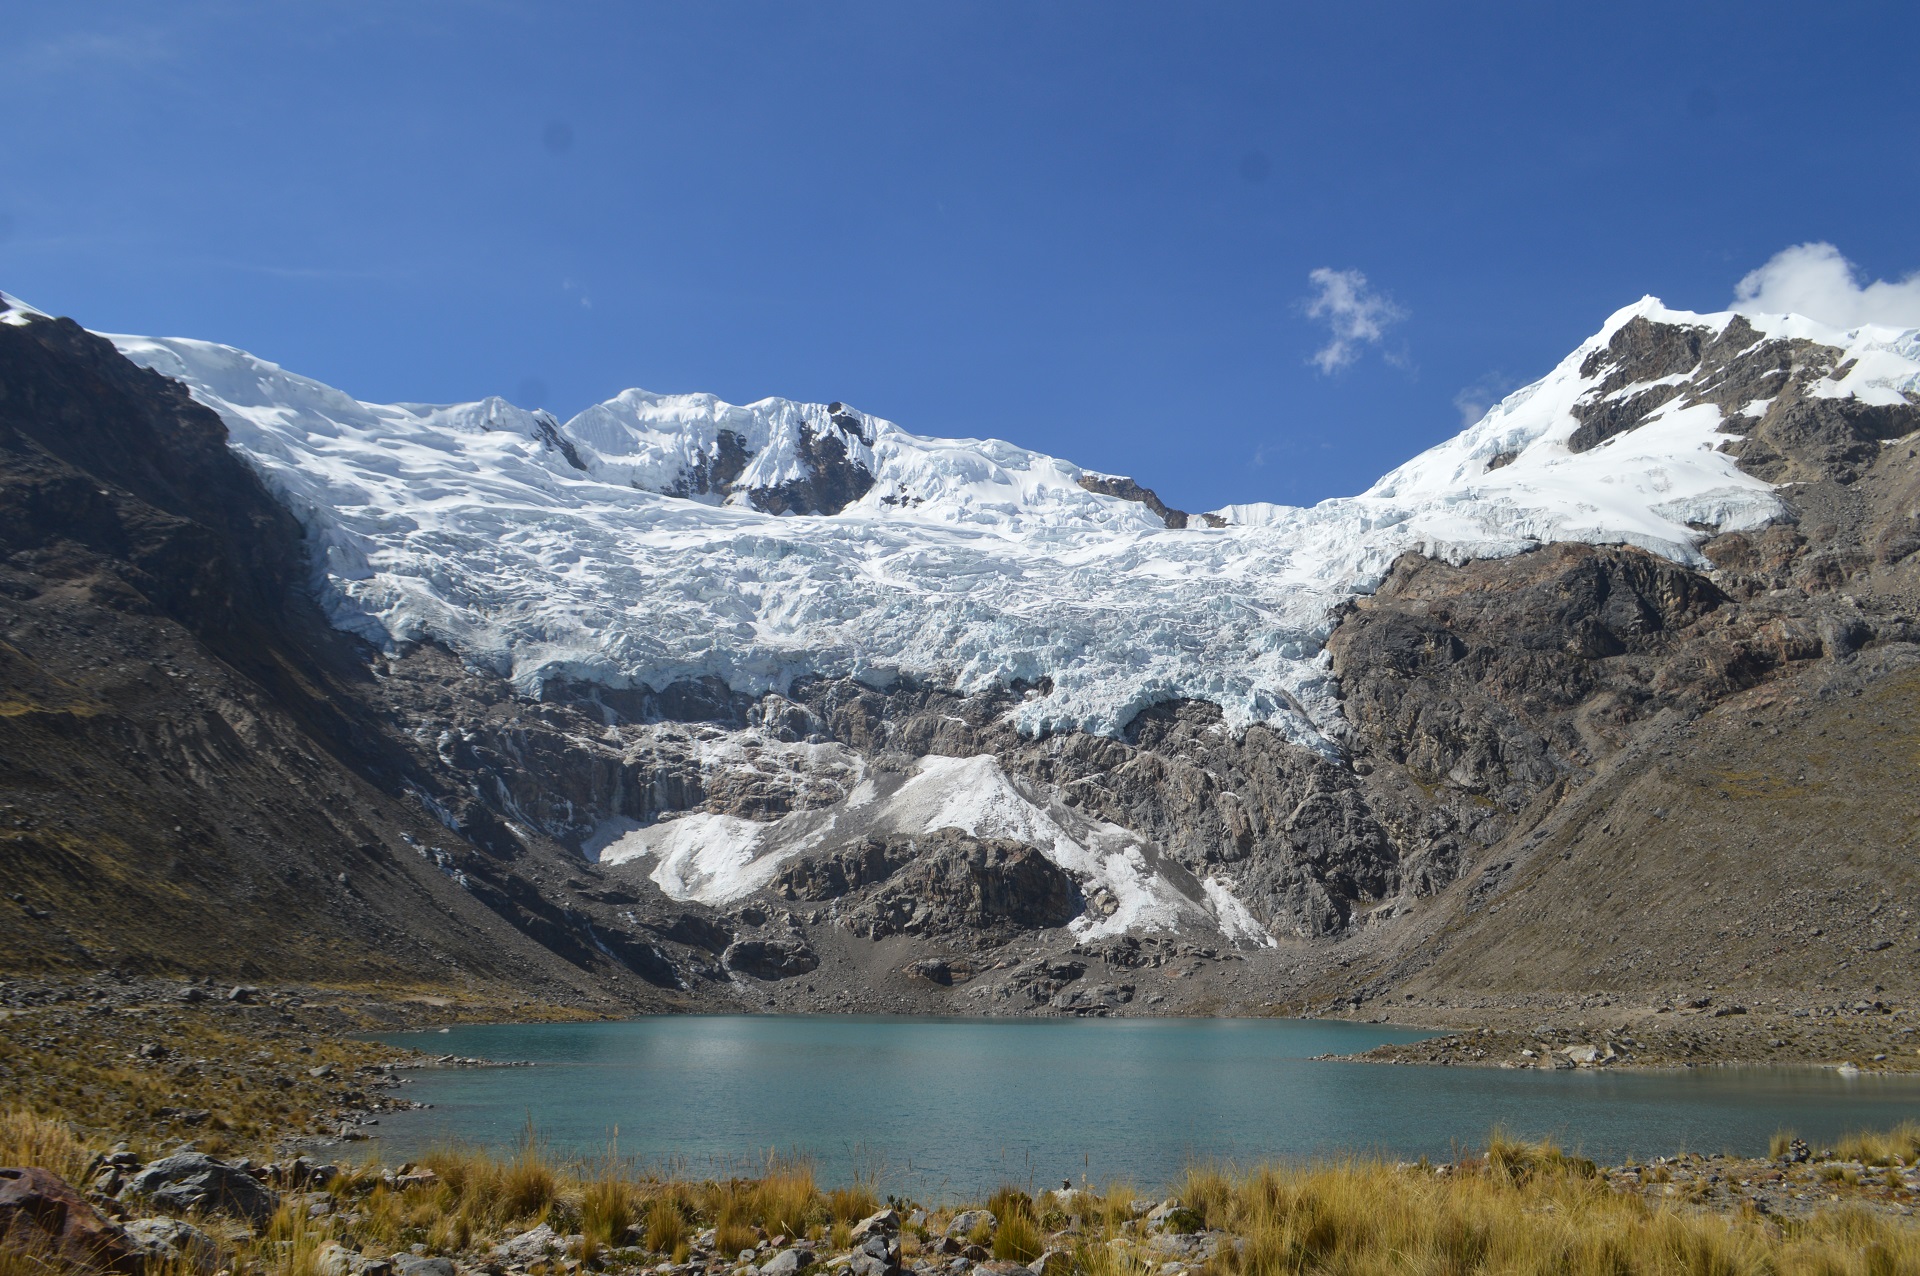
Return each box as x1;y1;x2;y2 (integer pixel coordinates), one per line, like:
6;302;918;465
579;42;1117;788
0;285;1920;1013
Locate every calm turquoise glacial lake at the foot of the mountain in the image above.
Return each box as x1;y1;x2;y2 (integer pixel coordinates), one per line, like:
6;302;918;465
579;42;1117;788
378;1015;1920;1201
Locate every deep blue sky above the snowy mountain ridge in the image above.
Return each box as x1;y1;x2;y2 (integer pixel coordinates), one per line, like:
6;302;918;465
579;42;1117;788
0;0;1920;508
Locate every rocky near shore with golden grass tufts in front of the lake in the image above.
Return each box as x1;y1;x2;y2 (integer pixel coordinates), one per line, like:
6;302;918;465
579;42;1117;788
0;1113;1920;1276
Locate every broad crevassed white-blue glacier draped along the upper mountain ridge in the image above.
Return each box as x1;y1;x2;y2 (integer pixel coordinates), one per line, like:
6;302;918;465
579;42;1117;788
111;297;1920;752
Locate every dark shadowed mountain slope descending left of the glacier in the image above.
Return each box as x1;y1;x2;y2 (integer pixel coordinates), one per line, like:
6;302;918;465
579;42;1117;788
0;311;721;1002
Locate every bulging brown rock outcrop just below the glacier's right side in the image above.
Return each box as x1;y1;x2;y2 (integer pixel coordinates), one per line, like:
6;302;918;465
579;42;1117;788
1331;545;1753;812
